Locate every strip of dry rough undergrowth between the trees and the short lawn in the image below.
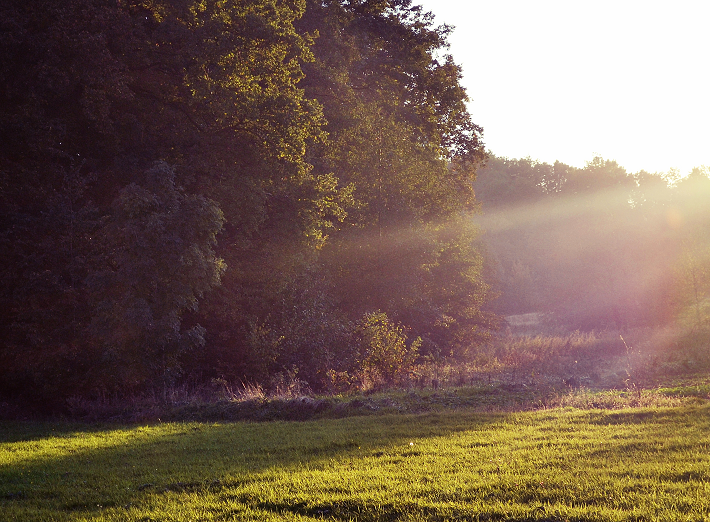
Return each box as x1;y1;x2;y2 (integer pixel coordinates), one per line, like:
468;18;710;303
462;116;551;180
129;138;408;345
0;328;710;422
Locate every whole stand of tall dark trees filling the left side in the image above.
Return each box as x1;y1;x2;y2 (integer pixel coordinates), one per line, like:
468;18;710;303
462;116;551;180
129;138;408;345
0;0;492;408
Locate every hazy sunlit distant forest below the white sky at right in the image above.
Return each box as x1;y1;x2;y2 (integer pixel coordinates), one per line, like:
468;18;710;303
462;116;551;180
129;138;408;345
474;156;710;331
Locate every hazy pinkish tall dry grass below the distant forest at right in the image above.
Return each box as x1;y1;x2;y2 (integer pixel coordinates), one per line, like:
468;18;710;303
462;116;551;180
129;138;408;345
406;327;710;390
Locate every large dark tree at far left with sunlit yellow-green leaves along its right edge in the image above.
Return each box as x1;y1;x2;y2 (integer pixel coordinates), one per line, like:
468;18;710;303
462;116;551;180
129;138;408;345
0;0;340;400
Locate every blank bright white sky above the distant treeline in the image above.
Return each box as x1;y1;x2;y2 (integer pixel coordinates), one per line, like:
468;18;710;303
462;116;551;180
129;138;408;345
413;0;710;174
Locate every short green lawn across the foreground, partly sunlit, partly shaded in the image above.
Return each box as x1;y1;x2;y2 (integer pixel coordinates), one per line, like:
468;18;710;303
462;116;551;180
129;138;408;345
0;401;710;522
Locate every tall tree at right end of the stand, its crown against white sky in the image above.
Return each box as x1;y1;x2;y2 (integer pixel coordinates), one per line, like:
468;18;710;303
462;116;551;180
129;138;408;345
298;0;496;358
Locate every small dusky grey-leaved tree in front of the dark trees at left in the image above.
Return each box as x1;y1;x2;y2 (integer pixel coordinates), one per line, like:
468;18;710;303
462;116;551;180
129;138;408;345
87;163;224;388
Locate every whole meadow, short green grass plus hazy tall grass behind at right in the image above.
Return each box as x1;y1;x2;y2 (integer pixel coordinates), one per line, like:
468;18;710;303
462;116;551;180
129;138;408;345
0;328;710;522
